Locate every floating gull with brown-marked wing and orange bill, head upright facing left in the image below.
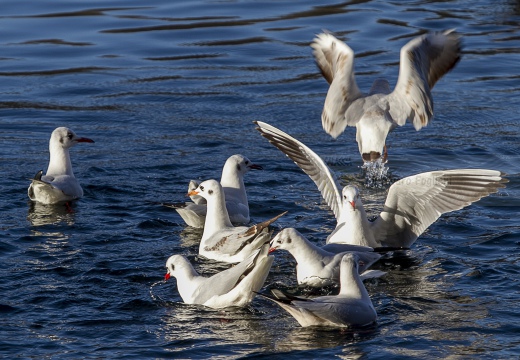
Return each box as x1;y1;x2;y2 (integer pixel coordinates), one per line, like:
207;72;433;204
188;179;287;263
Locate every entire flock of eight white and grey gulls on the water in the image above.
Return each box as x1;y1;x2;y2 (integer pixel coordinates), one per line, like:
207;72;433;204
28;30;507;328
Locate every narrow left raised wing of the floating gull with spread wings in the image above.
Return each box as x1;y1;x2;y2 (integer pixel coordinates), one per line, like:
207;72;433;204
255;121;341;220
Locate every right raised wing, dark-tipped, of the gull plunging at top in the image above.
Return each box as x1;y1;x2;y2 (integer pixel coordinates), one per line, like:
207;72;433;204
385;30;462;130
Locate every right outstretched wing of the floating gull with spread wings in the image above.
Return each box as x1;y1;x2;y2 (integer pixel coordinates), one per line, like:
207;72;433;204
371;169;507;247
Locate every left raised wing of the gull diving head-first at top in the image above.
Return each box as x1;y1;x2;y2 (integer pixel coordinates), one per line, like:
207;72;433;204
311;33;363;138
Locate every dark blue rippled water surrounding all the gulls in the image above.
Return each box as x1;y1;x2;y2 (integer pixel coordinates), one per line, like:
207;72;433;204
0;0;520;359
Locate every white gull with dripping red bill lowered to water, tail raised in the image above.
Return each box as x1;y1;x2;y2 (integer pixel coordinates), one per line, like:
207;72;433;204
164;245;274;309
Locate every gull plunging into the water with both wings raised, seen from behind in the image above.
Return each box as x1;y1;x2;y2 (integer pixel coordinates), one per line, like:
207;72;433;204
311;30;462;162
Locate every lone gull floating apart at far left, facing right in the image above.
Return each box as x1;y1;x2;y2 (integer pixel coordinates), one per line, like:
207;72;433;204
27;127;94;204
